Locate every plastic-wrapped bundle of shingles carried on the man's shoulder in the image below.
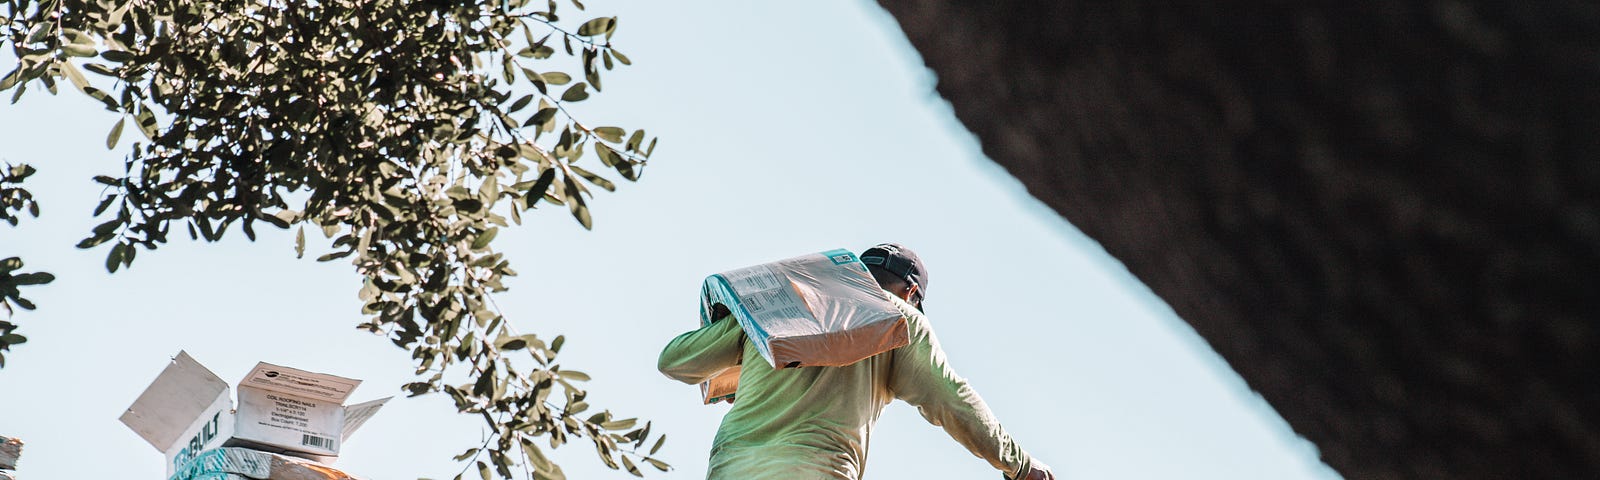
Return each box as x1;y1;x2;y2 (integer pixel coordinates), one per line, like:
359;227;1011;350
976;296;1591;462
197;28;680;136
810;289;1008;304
701;250;909;403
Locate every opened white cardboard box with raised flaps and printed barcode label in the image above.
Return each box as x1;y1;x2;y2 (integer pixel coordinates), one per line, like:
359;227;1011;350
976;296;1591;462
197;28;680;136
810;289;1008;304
122;352;392;475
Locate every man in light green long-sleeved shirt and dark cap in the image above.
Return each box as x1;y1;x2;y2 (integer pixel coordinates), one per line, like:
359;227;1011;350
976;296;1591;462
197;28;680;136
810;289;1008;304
658;243;1054;480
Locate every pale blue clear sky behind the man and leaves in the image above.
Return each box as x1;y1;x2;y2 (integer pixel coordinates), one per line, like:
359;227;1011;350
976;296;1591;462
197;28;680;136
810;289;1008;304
0;0;1336;480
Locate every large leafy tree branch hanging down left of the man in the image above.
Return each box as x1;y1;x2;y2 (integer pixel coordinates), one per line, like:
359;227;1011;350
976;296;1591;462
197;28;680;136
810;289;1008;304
0;0;667;478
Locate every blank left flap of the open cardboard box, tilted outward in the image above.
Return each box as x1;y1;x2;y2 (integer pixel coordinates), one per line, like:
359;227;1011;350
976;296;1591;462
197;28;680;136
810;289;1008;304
122;350;229;451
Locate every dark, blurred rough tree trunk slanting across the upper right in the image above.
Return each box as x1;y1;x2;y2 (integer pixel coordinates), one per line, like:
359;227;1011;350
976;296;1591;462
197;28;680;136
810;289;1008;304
880;0;1600;478
